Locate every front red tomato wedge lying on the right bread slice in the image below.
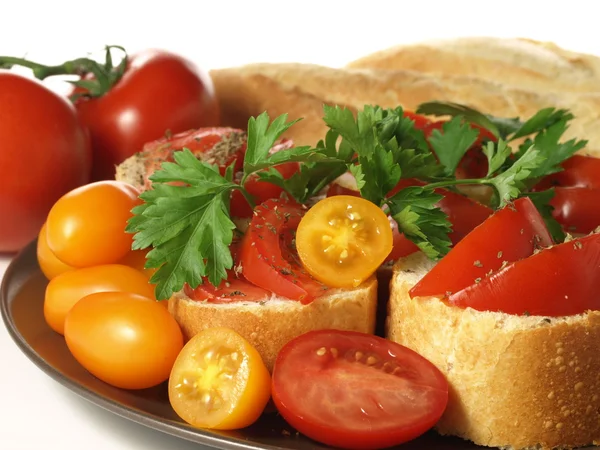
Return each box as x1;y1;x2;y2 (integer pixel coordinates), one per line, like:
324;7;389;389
448;234;600;316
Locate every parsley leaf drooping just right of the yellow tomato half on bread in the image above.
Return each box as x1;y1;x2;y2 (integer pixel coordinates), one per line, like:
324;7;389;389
387;186;452;259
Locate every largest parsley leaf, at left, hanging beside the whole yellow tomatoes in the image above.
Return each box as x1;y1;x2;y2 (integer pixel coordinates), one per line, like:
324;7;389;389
126;149;239;300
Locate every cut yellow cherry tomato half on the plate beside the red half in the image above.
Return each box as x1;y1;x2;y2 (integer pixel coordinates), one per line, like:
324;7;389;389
169;328;271;430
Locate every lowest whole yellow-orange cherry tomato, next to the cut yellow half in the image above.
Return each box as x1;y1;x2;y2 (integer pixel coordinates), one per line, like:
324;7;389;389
65;292;183;389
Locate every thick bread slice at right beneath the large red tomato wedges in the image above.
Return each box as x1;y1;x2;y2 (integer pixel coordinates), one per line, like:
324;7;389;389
386;253;600;449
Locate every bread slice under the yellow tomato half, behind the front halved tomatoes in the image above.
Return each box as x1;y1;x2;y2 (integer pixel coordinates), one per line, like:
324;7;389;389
169;277;377;371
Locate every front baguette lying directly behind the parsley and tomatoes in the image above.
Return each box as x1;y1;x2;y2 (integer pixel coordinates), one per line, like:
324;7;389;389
211;63;600;156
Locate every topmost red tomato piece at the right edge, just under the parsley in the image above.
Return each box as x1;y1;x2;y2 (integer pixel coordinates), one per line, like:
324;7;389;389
535;155;600;191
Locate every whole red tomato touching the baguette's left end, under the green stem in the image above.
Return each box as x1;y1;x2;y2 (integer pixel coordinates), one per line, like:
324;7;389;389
74;50;219;180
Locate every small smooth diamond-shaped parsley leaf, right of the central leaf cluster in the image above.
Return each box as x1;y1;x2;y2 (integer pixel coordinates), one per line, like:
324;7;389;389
429;117;479;176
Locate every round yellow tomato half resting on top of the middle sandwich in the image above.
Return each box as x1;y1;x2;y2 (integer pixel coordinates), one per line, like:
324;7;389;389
296;195;393;288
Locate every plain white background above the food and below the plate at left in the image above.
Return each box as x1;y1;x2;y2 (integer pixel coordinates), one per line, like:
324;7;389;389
0;0;600;450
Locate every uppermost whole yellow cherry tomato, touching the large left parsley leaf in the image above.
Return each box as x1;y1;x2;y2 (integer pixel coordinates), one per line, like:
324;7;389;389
46;180;141;267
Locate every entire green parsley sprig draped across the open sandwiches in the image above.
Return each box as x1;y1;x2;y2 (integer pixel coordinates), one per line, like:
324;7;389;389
127;103;586;299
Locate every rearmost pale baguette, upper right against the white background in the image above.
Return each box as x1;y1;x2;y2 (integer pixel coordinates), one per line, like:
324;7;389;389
347;37;600;92
